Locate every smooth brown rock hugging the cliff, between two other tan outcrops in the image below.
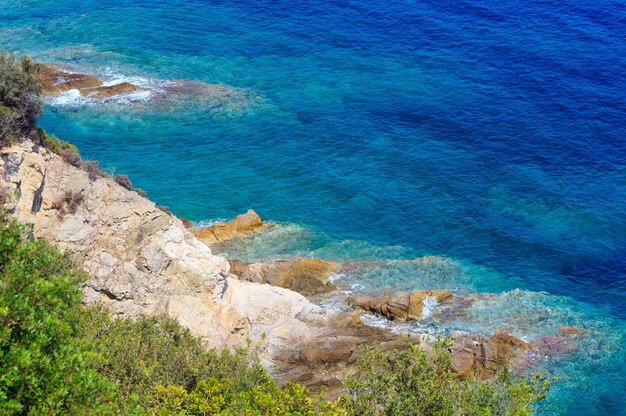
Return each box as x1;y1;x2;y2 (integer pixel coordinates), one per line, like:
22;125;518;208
229;258;337;295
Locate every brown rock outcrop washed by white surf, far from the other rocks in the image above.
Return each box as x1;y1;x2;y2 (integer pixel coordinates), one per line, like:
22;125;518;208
39;64;143;98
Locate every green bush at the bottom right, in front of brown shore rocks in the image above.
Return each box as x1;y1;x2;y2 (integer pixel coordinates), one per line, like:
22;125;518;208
342;339;549;416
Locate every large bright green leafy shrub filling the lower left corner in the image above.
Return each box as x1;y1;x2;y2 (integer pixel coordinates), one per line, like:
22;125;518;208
0;214;115;415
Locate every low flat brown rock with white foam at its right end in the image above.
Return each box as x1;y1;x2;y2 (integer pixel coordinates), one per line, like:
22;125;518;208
348;290;453;321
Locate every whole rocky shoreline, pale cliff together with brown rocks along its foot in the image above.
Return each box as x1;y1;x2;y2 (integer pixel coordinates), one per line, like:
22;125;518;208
0;140;584;396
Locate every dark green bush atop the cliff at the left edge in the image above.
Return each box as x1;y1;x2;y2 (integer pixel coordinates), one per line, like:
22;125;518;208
0;52;42;146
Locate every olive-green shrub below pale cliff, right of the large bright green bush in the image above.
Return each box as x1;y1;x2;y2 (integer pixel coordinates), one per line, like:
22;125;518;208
80;307;271;404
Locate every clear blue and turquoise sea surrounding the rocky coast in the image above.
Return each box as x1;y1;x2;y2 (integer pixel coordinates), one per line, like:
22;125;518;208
0;0;626;415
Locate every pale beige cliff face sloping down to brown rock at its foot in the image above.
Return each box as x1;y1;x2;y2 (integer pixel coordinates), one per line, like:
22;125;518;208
0;141;410;385
